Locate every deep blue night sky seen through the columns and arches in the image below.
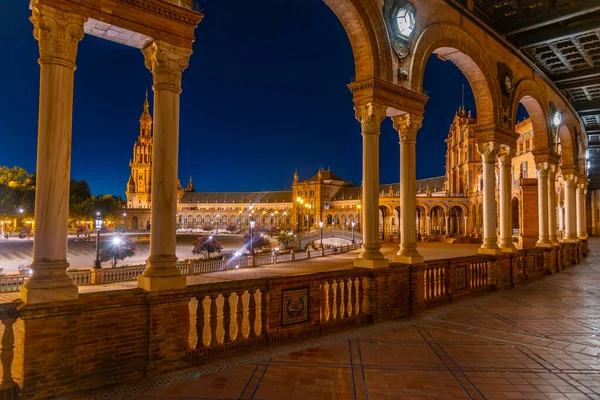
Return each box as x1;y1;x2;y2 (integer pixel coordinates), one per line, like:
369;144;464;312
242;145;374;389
0;0;474;197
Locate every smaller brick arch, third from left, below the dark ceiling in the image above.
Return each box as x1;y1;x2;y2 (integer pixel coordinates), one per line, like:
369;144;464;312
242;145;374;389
511;79;551;150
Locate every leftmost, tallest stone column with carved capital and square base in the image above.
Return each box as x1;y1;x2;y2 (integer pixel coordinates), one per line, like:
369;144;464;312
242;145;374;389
21;1;86;304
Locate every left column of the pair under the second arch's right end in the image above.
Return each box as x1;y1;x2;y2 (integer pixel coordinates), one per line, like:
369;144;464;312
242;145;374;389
477;142;502;254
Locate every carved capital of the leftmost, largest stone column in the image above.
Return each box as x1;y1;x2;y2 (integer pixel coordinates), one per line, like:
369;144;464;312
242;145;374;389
29;0;87;70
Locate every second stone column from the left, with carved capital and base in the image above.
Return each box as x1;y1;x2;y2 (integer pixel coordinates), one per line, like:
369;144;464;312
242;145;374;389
138;40;192;291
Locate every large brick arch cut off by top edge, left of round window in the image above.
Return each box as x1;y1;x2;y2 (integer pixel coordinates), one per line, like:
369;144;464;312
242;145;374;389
323;0;392;82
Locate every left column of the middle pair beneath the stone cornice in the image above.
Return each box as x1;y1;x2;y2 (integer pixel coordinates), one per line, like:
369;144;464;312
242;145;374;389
354;103;389;268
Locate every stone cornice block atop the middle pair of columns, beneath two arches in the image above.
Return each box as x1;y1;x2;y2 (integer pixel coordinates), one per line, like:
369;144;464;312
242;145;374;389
348;78;429;116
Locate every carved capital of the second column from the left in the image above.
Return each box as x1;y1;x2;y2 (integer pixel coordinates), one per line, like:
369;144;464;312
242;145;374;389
142;40;192;92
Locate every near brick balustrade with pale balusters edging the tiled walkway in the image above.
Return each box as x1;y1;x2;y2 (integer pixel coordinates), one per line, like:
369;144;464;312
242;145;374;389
0;239;587;399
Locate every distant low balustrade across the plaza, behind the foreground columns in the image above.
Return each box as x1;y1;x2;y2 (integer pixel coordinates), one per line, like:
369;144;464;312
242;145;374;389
0;243;361;292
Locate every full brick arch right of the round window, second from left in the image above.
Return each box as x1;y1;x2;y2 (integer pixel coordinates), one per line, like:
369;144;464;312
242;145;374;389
409;23;501;124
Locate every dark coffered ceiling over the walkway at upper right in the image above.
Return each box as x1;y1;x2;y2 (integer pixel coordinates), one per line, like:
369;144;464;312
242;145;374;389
447;0;600;189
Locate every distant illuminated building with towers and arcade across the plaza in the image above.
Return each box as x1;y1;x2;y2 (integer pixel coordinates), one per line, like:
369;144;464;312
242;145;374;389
124;100;576;247
